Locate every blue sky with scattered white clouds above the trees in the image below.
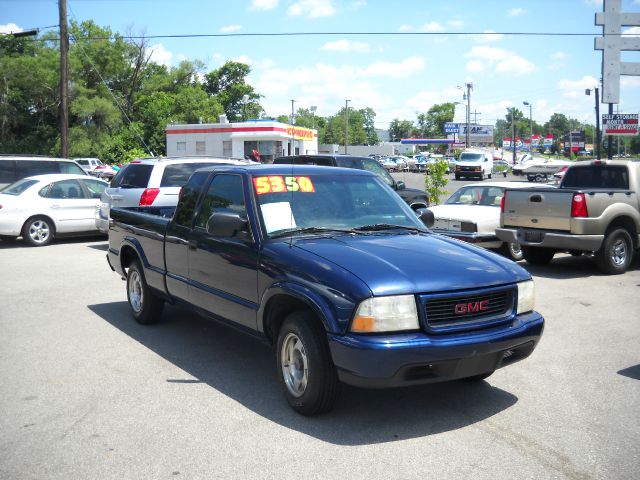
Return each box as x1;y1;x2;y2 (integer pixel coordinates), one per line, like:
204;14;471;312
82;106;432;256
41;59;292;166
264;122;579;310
0;0;640;128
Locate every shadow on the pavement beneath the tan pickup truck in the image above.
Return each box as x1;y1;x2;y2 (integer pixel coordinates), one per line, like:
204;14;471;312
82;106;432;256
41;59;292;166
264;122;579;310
519;253;640;280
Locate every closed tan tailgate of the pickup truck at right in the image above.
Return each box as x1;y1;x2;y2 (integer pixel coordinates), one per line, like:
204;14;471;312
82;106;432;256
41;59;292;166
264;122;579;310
501;189;574;231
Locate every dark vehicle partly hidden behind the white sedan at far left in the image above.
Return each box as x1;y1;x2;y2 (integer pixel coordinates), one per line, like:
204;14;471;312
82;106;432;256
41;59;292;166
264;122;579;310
0;155;88;188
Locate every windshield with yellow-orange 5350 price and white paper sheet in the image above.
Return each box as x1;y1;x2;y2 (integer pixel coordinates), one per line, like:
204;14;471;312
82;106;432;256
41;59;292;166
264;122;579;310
253;174;426;237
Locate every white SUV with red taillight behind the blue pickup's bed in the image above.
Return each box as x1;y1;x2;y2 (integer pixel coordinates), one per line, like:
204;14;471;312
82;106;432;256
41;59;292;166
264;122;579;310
96;156;255;233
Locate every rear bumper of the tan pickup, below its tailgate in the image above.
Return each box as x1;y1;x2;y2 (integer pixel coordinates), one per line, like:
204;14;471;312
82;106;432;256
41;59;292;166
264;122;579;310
496;227;604;252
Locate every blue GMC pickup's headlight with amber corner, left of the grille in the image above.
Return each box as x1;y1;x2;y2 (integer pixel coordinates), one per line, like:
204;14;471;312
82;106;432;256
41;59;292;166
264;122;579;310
351;295;419;333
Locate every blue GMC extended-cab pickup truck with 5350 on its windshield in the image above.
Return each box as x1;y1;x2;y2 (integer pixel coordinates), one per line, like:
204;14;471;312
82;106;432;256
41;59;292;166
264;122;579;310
107;165;544;415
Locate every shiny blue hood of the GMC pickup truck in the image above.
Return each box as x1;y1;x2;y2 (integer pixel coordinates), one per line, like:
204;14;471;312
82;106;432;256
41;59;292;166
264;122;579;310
294;232;530;295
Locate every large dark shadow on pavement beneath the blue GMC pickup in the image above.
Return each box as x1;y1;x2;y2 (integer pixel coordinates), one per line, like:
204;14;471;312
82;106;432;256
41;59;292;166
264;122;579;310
88;302;518;445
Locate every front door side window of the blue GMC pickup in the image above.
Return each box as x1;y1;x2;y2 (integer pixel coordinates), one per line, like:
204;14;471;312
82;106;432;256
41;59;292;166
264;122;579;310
195;174;246;228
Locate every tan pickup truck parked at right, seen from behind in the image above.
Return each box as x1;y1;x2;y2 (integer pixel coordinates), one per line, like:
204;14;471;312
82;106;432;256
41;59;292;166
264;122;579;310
496;160;640;274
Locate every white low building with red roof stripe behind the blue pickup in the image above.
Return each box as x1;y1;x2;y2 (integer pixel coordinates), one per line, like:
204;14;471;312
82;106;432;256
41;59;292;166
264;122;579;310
166;115;318;162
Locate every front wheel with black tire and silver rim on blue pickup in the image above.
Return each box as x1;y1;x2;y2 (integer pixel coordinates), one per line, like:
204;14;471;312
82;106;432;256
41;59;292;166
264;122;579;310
276;312;338;416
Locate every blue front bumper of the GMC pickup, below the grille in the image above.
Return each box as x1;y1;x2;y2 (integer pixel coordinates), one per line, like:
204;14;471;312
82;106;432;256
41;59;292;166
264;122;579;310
328;312;544;388
